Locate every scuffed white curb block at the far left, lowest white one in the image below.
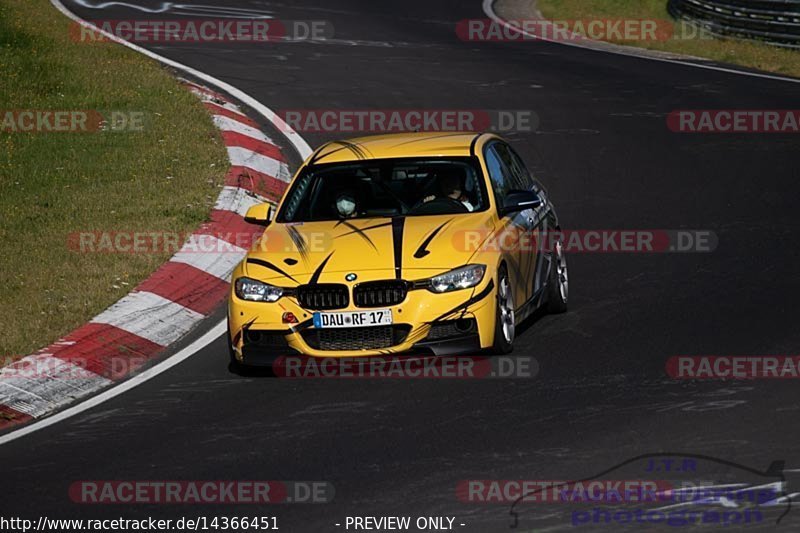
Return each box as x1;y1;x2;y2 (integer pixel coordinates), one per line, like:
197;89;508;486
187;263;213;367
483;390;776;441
0;354;112;418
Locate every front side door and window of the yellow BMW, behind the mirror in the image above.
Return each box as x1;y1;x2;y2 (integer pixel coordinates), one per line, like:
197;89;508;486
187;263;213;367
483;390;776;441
484;141;532;309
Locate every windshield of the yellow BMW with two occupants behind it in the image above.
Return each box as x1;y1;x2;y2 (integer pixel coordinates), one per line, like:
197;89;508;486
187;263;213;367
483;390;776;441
277;158;489;222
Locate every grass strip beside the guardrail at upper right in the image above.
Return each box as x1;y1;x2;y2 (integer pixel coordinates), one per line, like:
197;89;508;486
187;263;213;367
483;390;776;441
538;0;800;77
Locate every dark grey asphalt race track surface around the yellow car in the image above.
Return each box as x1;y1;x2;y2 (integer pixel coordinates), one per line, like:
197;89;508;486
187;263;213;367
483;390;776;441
0;0;800;531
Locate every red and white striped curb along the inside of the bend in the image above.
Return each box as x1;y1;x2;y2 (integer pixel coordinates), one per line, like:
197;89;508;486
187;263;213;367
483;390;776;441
0;80;291;430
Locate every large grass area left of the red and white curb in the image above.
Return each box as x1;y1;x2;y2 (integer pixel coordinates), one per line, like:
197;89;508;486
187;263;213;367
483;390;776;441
0;0;227;365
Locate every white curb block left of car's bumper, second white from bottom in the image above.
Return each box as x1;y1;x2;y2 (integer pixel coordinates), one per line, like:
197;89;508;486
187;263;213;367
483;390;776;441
92;290;206;346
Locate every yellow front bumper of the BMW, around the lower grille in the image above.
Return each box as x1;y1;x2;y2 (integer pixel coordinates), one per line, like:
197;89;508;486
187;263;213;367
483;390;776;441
228;275;496;366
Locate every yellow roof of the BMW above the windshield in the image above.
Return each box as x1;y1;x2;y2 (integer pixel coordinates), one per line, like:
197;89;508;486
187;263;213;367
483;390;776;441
309;132;480;165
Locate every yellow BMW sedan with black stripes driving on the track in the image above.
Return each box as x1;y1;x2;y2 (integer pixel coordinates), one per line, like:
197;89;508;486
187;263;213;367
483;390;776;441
228;133;569;366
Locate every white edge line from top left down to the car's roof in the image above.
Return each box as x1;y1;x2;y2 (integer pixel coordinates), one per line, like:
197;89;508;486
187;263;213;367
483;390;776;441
50;0;312;160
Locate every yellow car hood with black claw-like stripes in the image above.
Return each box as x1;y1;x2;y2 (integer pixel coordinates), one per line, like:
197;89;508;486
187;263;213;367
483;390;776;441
245;213;494;286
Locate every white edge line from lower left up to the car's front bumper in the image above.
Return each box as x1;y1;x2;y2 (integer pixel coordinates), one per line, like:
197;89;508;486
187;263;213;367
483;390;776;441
0;320;227;445
